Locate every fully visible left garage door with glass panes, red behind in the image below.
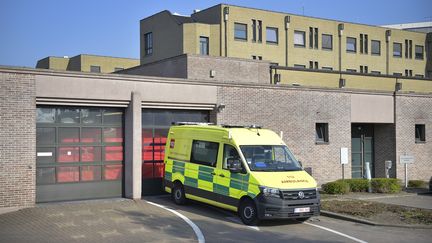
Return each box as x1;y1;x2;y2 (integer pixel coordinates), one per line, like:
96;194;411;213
36;106;124;202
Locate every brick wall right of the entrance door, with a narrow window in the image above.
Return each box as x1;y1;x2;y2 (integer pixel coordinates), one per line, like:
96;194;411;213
396;95;432;181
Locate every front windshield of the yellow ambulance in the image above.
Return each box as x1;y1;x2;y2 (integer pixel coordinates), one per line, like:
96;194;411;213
240;145;302;171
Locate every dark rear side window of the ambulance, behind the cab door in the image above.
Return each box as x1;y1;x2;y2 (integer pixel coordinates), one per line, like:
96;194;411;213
191;140;219;167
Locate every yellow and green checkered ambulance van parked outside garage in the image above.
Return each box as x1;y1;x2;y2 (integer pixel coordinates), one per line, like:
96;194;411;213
163;123;320;225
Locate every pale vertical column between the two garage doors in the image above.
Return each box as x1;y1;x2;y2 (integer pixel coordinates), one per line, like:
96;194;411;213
125;92;142;199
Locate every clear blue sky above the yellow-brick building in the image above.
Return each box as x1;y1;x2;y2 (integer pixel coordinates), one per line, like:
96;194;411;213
0;0;432;67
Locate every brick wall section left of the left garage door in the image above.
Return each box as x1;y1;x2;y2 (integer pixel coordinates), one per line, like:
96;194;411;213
0;72;36;207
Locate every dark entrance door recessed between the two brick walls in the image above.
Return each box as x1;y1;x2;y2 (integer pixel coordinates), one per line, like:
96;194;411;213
351;124;374;178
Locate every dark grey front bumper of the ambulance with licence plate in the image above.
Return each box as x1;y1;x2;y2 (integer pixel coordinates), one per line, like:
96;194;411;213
255;193;320;219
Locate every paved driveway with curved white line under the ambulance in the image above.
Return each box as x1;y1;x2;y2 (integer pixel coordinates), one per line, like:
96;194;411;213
0;195;432;243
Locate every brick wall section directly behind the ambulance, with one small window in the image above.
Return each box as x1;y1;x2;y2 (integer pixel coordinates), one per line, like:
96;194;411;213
217;86;351;184
